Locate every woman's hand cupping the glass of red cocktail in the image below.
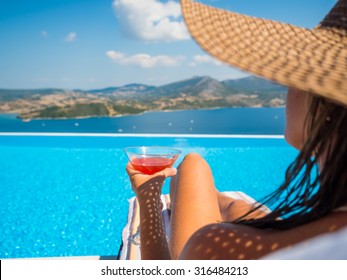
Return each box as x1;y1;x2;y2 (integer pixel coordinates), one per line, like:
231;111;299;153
126;162;177;196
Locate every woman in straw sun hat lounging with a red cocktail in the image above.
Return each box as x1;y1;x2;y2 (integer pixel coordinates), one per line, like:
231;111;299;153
127;0;347;259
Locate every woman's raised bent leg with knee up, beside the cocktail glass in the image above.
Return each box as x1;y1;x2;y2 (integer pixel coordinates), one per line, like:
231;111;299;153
170;154;222;259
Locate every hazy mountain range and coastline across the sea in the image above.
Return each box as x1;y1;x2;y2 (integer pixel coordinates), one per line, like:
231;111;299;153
0;76;286;119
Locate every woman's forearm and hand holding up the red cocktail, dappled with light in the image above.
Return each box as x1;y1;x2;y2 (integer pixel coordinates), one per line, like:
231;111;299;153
126;163;176;260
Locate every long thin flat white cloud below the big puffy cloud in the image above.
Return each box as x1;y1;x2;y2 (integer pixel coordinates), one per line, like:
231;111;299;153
106;51;183;68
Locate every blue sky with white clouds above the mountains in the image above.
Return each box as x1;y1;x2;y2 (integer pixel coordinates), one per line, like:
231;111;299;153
0;0;336;89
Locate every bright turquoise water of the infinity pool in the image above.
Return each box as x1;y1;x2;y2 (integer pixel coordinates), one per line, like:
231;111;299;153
0;134;297;258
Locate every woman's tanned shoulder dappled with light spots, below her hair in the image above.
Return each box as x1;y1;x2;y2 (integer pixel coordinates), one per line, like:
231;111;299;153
180;212;347;260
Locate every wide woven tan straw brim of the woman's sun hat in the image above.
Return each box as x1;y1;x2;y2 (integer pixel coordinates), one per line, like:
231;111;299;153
181;0;347;106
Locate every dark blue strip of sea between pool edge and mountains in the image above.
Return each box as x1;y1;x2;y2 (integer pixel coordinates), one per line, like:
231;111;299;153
0;108;285;135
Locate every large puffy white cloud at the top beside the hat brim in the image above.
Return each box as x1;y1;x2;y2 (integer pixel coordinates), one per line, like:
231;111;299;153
113;0;190;42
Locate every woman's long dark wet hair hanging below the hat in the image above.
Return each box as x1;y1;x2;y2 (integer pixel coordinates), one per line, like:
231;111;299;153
233;96;347;229
